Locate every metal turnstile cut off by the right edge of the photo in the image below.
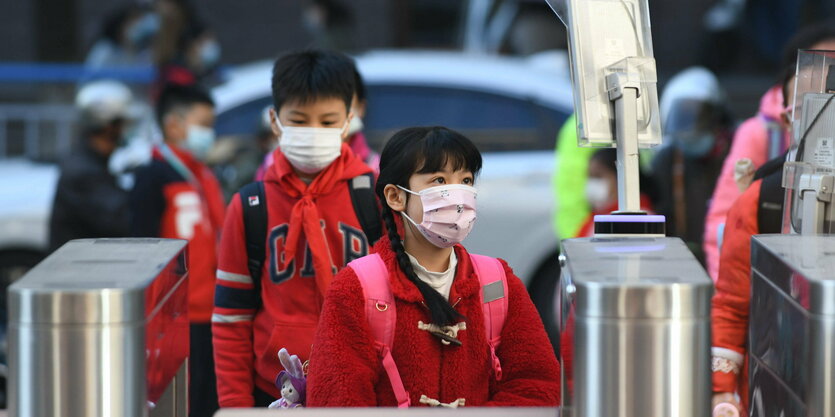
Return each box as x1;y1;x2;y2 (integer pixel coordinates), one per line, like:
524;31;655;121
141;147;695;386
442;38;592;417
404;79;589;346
748;235;835;417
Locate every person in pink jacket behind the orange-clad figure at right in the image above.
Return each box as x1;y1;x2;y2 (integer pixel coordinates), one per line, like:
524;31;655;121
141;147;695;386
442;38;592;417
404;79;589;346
703;23;835;281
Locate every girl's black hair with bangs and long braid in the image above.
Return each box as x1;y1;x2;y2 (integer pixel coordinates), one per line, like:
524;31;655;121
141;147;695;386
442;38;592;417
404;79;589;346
376;127;481;326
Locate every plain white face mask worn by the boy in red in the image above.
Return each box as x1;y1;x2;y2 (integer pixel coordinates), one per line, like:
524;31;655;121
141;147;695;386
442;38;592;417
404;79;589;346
275;117;348;174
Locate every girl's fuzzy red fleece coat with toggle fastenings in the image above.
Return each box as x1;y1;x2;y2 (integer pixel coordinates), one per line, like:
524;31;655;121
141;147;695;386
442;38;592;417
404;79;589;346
307;239;560;407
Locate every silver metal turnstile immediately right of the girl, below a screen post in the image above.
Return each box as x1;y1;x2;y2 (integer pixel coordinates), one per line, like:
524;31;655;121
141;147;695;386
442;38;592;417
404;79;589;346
557;237;713;417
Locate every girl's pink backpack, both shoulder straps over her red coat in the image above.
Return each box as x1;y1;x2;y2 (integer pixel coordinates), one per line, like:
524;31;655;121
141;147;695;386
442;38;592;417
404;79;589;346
348;253;508;408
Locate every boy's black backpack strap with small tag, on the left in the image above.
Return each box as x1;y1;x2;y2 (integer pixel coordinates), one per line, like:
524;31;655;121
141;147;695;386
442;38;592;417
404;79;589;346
239;181;267;302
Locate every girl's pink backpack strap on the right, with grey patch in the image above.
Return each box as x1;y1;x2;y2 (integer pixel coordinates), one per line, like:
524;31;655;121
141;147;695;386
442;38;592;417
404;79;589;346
470;254;508;381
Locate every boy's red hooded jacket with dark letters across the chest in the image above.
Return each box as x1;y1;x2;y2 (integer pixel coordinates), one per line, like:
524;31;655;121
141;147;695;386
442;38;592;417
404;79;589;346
212;145;371;407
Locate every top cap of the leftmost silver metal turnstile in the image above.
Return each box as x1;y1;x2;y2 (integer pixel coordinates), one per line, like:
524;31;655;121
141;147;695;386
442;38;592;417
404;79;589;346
9;239;187;325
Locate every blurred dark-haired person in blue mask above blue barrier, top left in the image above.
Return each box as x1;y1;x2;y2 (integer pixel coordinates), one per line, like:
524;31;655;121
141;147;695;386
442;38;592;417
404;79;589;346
84;4;160;69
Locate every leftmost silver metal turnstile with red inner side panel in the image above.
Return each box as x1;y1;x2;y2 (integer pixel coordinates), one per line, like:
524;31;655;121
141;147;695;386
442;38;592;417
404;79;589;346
8;239;189;417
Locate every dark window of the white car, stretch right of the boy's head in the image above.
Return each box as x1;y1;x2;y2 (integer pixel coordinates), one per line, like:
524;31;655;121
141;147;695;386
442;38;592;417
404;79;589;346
363;85;568;152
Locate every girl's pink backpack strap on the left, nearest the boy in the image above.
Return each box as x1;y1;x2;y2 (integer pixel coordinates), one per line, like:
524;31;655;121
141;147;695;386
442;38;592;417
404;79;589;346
348;253;410;408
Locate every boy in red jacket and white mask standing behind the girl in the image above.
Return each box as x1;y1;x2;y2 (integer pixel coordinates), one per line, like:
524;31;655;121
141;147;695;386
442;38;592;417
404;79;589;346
212;51;378;407
